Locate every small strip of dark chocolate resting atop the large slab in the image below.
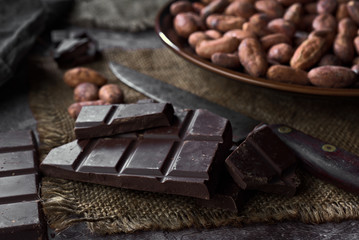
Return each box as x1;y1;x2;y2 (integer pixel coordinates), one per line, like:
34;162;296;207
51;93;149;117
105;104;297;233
75;103;174;139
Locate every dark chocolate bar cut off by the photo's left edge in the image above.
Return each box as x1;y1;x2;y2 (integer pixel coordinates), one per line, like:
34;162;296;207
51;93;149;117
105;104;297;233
0;131;47;240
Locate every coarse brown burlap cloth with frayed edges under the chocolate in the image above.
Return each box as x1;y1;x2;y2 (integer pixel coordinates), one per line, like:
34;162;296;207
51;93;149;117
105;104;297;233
30;49;359;234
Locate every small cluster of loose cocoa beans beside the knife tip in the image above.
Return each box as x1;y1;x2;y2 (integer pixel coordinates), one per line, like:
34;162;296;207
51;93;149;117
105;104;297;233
64;67;124;119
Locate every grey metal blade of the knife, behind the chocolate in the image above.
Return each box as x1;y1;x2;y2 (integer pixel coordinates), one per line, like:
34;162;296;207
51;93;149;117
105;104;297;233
109;63;260;142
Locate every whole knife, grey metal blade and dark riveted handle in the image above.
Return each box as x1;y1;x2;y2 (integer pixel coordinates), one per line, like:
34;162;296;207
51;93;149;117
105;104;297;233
109;63;359;194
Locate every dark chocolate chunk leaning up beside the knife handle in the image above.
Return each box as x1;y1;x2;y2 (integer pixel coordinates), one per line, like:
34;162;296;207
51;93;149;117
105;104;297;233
226;124;297;195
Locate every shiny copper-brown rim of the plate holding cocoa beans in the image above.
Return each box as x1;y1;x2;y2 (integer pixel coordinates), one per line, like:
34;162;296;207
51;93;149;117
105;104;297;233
155;1;359;97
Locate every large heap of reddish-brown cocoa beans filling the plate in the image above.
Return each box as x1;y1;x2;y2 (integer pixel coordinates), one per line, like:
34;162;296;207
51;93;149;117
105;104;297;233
170;0;359;88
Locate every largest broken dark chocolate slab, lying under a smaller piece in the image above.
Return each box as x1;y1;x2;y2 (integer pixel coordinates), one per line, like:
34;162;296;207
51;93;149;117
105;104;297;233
40;110;232;199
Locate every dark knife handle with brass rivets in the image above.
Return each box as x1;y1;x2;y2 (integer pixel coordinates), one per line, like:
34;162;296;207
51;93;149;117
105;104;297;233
269;125;359;194
